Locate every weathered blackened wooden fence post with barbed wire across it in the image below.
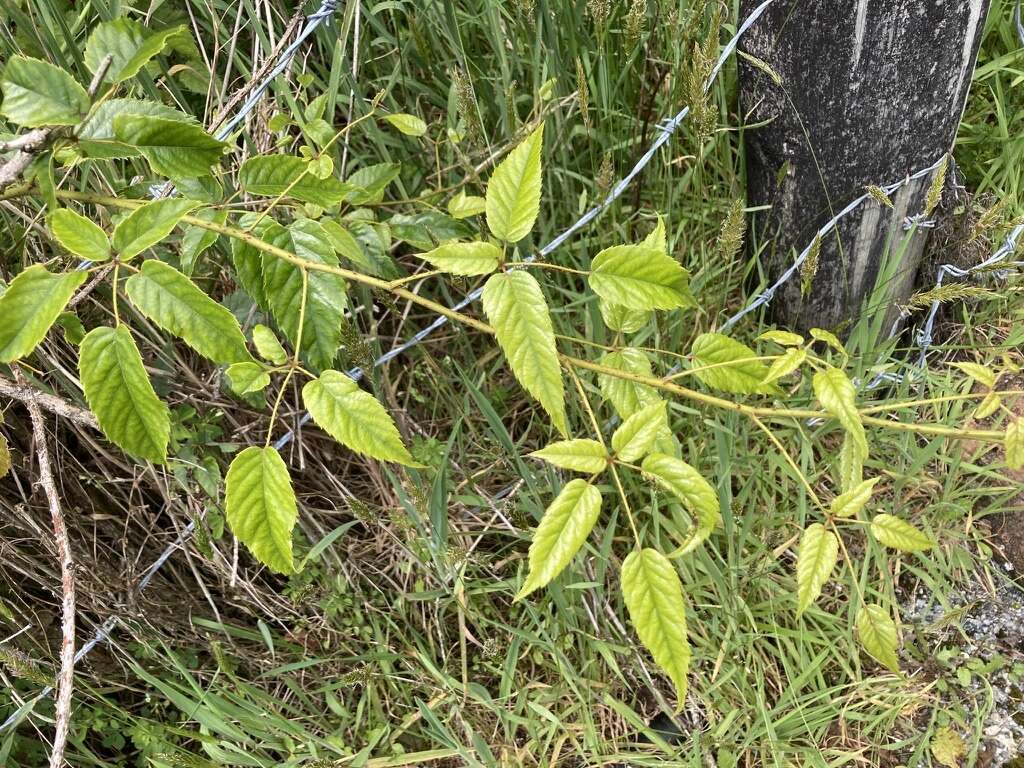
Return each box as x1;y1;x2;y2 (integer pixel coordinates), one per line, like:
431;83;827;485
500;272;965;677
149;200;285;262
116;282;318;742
740;0;989;329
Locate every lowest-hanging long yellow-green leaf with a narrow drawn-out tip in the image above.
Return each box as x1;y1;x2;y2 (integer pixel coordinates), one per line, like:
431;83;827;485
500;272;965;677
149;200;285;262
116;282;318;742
623;549;690;712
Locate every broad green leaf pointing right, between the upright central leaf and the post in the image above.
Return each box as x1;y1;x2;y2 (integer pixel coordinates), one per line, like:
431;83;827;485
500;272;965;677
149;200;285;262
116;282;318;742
589;245;695;309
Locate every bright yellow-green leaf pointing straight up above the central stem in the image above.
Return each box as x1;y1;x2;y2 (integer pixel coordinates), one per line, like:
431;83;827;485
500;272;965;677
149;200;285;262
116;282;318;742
485;123;544;243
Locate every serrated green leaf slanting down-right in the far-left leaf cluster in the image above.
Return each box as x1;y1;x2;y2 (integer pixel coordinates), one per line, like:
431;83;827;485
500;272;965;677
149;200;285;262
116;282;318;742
125;259;252;365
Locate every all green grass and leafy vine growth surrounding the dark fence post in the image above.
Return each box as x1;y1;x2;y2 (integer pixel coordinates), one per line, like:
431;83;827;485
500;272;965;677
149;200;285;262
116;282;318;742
0;0;1024;768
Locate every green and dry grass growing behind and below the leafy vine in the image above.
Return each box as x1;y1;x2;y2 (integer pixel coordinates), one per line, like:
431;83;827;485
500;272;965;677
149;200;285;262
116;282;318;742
0;0;1024;768
